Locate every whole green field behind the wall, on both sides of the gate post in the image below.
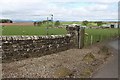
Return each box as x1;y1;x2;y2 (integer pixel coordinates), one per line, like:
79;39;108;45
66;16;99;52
0;25;118;46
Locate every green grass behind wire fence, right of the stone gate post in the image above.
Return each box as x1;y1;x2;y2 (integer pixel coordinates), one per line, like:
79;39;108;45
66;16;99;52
85;29;118;45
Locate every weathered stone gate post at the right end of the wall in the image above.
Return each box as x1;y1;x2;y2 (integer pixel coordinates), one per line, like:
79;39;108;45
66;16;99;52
66;25;85;49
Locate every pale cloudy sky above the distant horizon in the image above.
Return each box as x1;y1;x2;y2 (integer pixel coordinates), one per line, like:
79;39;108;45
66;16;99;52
0;0;119;21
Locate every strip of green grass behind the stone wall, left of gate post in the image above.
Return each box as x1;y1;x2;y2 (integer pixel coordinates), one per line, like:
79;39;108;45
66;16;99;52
2;26;67;35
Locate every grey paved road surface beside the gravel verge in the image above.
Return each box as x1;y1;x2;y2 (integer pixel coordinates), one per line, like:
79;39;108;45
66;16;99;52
93;40;118;78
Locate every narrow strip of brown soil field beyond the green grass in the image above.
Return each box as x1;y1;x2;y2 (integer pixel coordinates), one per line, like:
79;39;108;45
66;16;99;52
0;22;33;26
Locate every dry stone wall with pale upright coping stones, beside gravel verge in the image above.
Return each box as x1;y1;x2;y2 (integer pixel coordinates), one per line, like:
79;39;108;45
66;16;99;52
0;34;74;62
